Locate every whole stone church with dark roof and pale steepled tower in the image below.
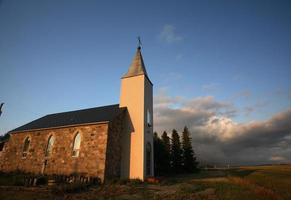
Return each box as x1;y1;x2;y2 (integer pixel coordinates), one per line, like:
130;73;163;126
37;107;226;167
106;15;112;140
0;47;153;180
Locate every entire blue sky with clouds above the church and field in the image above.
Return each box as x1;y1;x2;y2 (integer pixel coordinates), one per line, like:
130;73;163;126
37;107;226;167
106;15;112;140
0;0;291;164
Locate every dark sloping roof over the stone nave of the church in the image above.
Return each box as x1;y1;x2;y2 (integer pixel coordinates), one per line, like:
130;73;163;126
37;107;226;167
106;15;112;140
10;104;126;133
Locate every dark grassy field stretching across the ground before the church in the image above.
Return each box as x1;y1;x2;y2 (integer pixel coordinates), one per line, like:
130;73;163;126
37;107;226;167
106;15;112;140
0;165;291;200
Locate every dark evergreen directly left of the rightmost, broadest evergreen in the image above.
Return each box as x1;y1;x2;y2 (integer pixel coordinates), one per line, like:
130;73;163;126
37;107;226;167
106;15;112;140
171;129;182;174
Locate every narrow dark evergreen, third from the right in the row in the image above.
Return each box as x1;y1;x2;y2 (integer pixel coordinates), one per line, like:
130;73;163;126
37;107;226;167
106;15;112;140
162;131;171;174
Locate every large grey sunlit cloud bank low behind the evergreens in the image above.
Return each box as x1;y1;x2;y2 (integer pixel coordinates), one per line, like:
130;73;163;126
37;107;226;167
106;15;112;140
154;92;291;165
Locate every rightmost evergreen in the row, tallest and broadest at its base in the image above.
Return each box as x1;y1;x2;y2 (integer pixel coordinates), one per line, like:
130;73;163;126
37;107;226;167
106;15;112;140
182;126;198;172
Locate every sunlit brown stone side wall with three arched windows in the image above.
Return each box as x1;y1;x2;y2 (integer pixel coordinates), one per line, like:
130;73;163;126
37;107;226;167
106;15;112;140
0;123;109;180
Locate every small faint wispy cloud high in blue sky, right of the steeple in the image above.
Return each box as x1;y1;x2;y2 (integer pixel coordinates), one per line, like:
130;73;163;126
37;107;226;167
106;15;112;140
159;24;183;44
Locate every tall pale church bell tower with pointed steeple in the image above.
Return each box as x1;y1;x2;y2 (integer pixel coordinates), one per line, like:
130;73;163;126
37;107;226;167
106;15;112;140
119;45;154;180
